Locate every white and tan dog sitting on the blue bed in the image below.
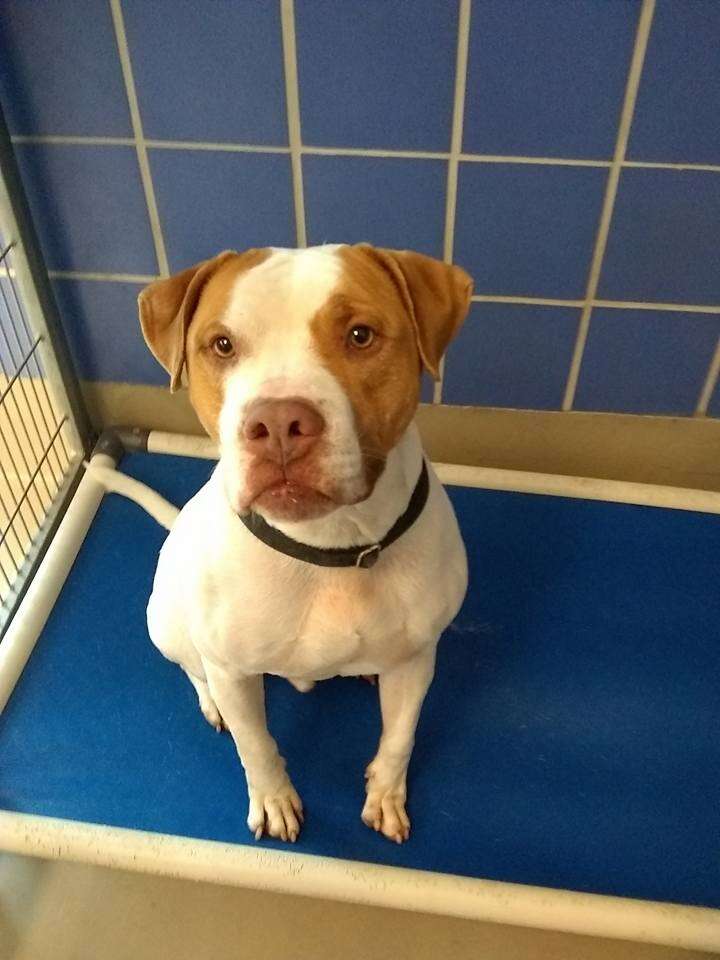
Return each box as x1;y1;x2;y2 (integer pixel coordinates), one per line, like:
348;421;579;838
107;245;472;843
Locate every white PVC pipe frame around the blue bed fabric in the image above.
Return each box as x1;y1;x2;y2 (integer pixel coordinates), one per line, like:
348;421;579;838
0;431;720;951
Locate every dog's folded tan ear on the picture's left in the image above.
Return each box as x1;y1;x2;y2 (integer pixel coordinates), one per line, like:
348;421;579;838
138;250;237;391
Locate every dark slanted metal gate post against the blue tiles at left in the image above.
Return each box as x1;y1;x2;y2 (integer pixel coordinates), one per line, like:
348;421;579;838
0;105;94;456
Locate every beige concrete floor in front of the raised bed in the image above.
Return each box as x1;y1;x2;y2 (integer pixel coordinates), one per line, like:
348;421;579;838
0;855;720;960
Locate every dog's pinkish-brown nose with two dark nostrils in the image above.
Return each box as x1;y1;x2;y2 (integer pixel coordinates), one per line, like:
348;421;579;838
242;400;325;466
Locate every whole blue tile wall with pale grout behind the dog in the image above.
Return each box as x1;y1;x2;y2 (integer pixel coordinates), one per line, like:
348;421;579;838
0;0;720;417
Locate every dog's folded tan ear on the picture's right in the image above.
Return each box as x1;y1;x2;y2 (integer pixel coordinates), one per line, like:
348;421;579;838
368;247;473;380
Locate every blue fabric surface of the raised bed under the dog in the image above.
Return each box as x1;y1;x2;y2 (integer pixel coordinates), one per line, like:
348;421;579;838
0;454;720;907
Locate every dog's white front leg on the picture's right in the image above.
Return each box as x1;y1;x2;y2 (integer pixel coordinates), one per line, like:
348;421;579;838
362;644;435;843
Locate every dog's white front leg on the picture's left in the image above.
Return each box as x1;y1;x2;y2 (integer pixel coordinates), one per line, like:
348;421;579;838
203;661;303;843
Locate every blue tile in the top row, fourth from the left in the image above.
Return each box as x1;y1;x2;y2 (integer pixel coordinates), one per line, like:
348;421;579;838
463;0;639;159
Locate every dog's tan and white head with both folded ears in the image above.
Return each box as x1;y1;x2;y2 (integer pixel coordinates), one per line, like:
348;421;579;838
139;244;472;520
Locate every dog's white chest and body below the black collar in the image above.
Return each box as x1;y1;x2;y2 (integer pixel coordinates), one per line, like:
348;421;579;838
148;468;467;680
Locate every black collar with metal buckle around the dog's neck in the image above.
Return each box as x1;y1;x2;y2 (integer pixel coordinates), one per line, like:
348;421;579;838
240;458;430;569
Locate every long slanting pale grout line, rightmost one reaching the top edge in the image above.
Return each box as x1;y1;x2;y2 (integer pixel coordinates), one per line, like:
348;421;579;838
562;0;655;410
